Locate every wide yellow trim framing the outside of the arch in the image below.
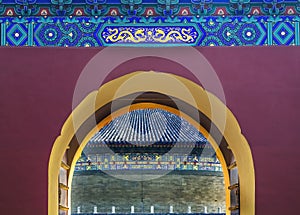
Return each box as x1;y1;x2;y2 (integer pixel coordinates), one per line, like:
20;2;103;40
48;71;255;215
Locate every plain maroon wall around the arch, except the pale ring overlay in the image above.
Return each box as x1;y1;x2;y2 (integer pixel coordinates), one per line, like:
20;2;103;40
0;47;300;215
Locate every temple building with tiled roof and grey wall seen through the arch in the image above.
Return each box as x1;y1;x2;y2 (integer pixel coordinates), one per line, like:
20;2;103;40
71;109;226;213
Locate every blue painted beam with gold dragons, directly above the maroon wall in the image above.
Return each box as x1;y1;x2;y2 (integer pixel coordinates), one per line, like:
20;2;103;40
0;15;300;47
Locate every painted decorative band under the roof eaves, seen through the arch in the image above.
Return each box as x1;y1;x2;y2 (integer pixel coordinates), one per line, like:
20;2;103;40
75;153;223;173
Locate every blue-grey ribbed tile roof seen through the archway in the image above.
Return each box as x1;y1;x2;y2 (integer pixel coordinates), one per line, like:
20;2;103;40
89;109;207;144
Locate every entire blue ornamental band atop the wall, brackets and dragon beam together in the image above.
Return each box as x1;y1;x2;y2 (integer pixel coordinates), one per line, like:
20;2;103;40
0;0;300;47
